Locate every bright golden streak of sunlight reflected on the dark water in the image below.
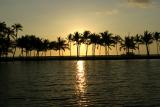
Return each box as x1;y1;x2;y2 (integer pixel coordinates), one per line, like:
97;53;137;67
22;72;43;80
76;61;89;106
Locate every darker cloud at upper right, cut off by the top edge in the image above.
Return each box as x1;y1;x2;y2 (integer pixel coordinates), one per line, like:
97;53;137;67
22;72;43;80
127;0;153;8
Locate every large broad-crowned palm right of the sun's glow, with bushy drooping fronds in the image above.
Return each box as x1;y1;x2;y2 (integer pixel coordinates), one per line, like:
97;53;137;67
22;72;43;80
100;31;114;55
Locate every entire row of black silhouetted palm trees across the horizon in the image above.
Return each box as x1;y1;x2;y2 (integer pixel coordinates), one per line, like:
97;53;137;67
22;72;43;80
0;22;160;58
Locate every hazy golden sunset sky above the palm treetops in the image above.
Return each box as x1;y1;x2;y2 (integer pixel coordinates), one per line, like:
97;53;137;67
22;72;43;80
0;0;160;55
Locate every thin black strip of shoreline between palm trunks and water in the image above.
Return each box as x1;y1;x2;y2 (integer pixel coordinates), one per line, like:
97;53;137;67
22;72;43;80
0;55;160;62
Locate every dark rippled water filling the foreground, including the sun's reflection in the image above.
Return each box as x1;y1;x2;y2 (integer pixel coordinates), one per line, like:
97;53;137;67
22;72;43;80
0;60;160;107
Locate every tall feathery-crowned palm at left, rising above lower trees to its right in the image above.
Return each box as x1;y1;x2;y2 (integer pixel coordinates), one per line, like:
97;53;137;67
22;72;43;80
12;23;23;58
